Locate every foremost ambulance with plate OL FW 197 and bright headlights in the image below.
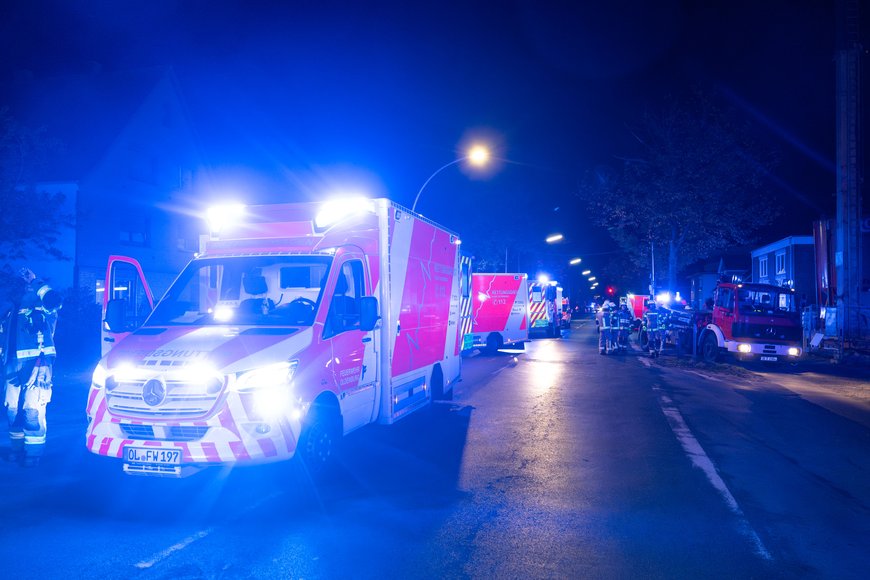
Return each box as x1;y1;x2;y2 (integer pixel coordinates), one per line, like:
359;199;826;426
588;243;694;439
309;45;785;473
86;199;469;477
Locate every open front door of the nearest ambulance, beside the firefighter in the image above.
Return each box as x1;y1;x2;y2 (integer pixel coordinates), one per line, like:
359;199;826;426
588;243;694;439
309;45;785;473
100;256;154;356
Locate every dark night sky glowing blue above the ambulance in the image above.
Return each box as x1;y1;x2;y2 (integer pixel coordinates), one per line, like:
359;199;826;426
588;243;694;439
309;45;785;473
0;0;866;280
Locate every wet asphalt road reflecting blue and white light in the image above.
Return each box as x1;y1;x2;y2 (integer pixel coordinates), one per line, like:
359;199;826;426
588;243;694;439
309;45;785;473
0;322;870;579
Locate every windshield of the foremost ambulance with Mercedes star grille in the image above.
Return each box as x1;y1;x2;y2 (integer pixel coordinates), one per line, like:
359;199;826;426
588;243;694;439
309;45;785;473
146;256;332;326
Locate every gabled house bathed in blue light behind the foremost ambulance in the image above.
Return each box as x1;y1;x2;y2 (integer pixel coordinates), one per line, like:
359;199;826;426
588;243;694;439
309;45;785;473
13;67;203;302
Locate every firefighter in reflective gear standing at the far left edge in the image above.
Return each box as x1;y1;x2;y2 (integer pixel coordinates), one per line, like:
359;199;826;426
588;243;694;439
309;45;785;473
4;268;62;466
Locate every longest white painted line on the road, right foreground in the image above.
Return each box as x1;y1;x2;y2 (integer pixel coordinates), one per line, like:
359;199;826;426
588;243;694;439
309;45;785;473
653;385;773;560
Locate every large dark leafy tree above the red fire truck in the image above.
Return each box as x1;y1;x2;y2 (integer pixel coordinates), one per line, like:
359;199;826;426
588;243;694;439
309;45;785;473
580;90;777;286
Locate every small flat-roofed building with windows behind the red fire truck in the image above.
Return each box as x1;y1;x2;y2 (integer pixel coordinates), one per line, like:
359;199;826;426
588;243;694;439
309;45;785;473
752;236;816;305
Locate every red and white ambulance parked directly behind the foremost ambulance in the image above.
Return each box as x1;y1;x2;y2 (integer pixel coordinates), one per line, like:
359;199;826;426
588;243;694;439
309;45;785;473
471;273;529;354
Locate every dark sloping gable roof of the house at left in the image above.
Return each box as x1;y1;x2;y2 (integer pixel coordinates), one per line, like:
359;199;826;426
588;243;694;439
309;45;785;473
9;67;172;181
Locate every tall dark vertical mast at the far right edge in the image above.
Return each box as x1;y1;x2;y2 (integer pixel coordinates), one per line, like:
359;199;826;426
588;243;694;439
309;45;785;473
834;0;870;347
